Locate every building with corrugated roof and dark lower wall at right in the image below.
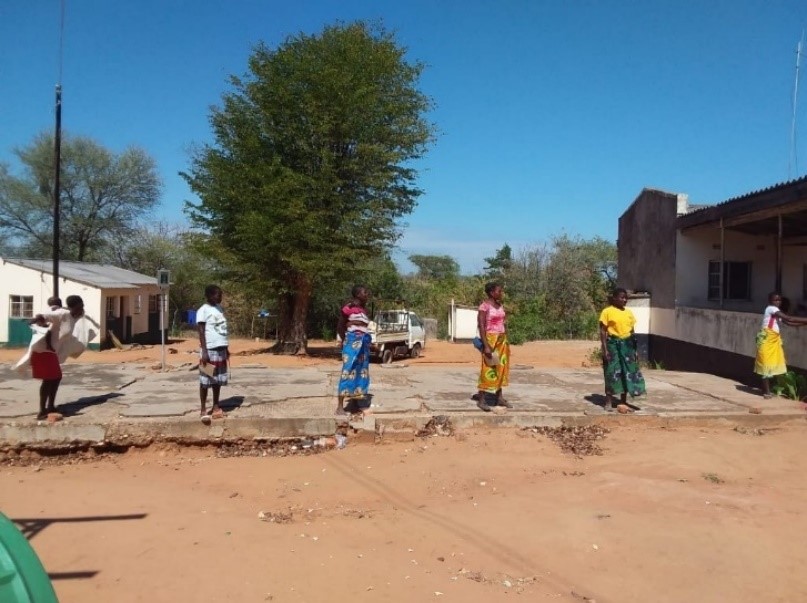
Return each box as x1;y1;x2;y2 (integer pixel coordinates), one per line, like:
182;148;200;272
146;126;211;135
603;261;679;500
618;177;807;382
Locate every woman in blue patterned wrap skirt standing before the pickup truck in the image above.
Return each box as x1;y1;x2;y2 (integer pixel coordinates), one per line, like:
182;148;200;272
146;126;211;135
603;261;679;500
336;285;370;415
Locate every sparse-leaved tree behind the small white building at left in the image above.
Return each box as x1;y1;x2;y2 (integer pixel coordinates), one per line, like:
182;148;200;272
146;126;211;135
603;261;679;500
0;134;161;261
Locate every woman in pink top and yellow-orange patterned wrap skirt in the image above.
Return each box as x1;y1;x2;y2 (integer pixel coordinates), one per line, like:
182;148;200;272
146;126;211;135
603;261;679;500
474;282;513;412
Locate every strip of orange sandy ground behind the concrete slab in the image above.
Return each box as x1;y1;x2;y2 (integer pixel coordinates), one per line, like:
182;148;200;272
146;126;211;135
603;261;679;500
0;339;599;368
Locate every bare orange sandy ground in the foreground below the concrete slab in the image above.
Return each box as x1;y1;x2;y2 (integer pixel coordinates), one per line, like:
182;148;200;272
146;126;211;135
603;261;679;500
0;427;807;603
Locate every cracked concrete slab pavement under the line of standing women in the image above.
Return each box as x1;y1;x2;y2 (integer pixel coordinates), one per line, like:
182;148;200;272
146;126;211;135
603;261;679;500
0;363;807;444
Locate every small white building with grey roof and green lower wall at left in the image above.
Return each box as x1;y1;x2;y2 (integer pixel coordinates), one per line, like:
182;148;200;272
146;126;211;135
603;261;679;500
0;258;166;349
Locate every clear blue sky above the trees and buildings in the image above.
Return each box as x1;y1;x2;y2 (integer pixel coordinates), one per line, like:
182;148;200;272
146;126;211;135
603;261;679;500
0;0;807;272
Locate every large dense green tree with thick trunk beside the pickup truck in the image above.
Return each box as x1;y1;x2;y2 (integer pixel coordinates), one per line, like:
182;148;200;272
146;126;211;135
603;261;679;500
184;22;434;352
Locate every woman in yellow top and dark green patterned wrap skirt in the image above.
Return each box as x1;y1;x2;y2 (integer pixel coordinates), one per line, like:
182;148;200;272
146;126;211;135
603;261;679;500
600;289;646;411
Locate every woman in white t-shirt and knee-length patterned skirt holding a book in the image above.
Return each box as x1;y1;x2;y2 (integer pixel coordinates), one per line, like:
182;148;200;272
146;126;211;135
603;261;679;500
196;285;230;424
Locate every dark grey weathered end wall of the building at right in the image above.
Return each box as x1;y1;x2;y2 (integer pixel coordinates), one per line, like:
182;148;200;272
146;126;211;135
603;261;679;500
617;189;683;308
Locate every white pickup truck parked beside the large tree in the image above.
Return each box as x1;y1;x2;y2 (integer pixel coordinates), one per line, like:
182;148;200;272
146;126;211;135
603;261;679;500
370;310;426;364
